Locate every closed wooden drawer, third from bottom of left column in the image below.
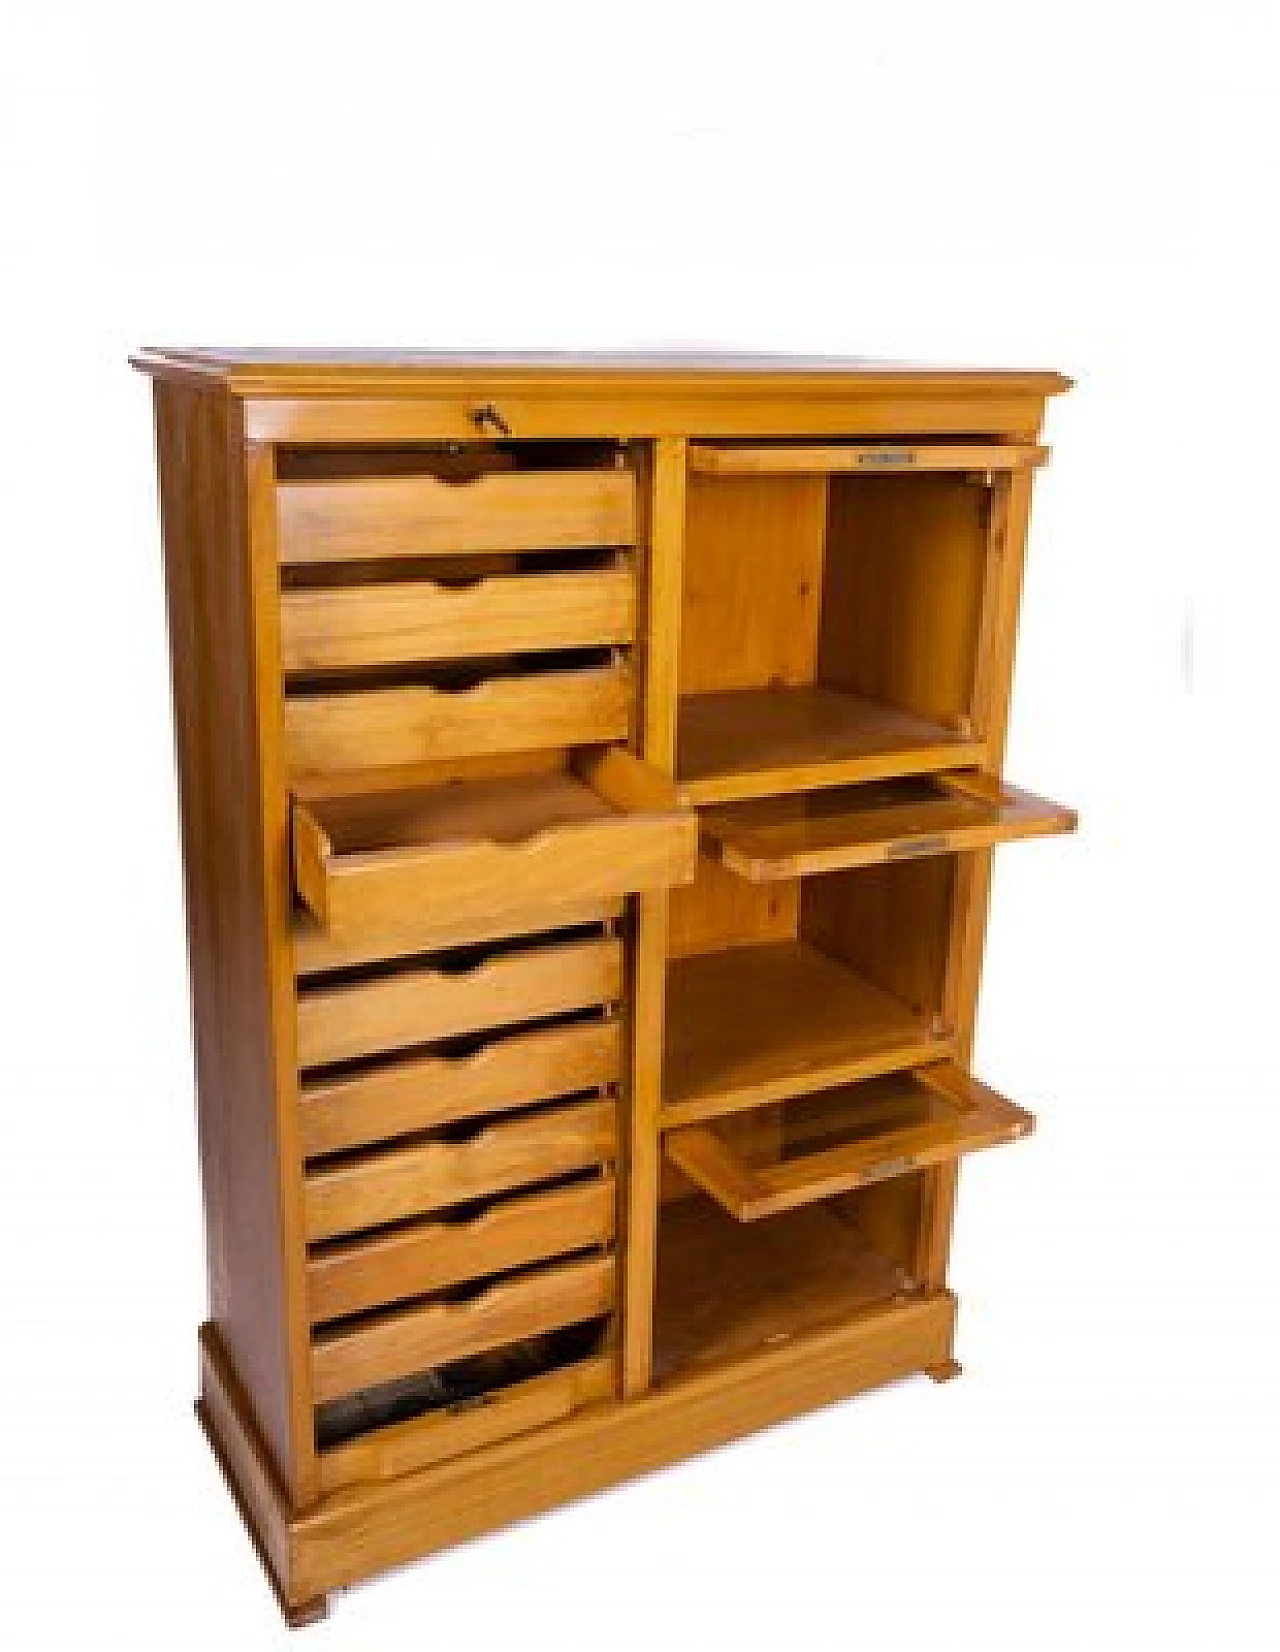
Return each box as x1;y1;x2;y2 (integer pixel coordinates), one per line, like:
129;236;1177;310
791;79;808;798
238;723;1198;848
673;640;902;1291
307;1175;616;1323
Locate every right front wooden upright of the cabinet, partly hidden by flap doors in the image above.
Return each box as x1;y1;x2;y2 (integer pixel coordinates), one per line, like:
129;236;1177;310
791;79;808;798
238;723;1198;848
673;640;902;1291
915;459;1034;1290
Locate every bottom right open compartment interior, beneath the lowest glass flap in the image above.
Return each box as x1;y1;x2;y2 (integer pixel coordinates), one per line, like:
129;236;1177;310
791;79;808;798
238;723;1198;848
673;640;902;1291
654;1198;915;1381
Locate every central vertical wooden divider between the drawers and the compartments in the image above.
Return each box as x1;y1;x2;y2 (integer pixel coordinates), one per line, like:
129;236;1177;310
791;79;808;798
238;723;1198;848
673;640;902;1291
621;436;687;1398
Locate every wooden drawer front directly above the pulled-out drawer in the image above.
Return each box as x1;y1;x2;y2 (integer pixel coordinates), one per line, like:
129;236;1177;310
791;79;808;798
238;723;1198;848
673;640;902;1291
284;661;631;775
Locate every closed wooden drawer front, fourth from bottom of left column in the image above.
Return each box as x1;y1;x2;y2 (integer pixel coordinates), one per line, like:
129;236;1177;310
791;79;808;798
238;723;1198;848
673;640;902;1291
304;1099;618;1242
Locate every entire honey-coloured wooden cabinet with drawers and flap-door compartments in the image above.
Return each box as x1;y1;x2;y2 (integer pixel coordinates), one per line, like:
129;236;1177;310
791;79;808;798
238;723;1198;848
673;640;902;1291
137;341;1074;1622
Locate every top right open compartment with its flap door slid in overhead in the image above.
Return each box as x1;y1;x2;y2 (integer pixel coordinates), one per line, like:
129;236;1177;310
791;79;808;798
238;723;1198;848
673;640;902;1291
677;443;1037;803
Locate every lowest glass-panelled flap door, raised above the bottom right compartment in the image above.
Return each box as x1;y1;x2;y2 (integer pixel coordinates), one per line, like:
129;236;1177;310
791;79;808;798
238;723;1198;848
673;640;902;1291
666;1061;1034;1222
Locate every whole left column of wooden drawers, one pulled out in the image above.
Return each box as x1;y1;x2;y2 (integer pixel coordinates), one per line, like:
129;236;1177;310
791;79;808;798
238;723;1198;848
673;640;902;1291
276;448;697;1488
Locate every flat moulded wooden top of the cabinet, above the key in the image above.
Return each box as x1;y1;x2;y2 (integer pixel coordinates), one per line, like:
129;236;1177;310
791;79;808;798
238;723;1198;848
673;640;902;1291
132;347;1070;395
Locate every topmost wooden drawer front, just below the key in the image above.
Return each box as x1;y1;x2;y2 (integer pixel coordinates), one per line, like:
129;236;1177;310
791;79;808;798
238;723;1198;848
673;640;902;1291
276;469;636;567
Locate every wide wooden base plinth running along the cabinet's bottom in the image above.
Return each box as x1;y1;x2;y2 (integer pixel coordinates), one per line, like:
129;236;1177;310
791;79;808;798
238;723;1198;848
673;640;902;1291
197;1292;960;1624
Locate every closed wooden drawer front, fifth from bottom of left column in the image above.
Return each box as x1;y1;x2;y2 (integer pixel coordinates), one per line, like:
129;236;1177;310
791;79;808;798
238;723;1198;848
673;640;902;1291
301;1018;623;1158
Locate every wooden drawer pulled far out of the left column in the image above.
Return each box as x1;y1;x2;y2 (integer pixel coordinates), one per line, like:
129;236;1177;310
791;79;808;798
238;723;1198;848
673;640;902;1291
294;748;697;933
